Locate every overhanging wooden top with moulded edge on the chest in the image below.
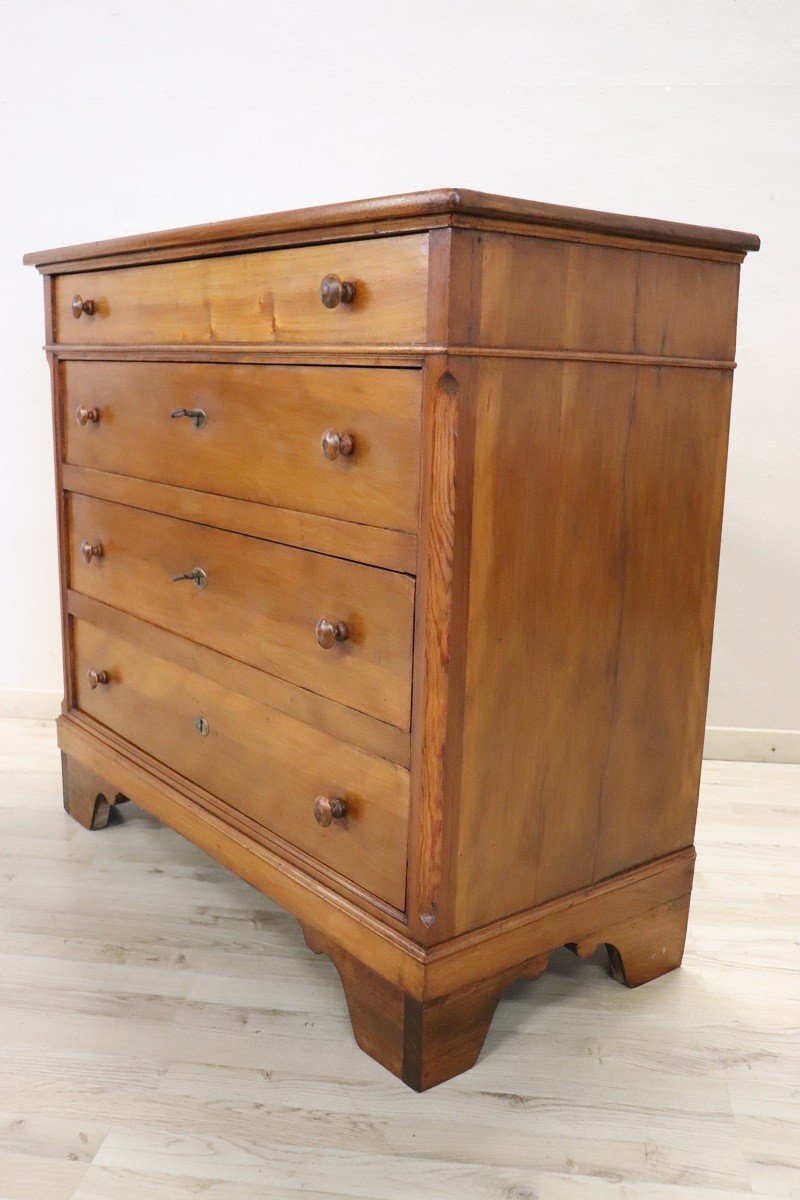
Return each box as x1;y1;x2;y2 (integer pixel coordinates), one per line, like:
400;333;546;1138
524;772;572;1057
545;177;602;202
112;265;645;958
23;187;760;266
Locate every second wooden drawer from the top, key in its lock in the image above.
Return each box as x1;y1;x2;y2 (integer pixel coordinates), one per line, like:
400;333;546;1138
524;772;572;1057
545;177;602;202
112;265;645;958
62;361;421;533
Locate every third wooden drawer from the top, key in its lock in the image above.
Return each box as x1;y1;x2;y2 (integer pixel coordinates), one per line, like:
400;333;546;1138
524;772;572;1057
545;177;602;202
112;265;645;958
68;493;414;730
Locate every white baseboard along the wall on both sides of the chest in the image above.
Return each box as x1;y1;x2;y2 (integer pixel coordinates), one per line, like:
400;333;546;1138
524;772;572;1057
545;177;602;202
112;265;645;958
0;688;800;763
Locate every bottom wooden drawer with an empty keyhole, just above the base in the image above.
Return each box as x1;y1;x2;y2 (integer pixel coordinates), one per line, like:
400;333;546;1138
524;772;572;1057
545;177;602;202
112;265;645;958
73;622;409;908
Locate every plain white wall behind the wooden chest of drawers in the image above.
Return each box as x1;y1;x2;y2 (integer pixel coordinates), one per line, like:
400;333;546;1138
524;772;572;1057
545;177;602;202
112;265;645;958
0;0;800;748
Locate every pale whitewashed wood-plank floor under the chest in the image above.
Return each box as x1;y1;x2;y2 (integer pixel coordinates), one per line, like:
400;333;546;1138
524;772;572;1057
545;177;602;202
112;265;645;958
0;720;800;1200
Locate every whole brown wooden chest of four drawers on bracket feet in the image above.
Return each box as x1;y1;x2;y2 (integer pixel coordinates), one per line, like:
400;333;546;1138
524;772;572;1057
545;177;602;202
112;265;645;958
26;191;758;1090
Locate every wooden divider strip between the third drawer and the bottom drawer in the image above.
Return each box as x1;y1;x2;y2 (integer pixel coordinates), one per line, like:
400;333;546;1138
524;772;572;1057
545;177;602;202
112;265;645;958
67;590;410;768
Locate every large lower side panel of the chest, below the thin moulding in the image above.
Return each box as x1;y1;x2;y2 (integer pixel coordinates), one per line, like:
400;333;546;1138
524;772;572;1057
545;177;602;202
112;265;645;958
453;359;732;932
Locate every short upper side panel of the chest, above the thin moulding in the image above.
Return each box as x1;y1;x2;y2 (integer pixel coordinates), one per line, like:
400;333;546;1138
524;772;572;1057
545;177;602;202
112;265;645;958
450;230;739;360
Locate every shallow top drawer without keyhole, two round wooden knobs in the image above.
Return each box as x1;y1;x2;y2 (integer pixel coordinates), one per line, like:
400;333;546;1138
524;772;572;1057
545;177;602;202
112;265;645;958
55;234;428;346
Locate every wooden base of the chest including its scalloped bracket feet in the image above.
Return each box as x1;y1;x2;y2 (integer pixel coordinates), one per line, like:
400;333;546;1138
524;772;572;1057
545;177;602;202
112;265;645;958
58;716;694;1091
